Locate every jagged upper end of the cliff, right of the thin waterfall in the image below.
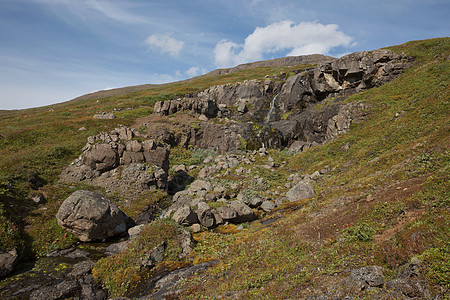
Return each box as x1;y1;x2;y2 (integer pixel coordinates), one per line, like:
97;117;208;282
278;49;411;115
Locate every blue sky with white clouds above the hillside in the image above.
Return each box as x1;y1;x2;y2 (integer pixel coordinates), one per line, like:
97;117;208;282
0;0;450;110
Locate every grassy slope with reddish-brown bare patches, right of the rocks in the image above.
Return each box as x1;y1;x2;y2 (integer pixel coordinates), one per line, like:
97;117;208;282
176;39;450;299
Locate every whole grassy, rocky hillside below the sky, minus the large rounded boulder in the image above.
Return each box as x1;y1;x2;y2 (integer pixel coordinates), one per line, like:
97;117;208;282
0;38;450;299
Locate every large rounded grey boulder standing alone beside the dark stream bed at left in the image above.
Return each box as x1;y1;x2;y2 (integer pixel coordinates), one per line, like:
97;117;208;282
56;190;129;242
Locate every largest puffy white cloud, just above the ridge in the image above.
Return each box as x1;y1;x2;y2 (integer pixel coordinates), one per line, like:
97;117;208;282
215;20;352;67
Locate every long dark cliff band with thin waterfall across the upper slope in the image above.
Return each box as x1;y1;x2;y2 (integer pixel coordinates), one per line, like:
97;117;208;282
154;50;411;153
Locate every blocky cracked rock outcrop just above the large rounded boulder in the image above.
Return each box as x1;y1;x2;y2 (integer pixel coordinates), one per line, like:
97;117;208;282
60;127;170;197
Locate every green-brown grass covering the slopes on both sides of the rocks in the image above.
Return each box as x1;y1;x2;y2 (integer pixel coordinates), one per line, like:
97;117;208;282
0;39;450;298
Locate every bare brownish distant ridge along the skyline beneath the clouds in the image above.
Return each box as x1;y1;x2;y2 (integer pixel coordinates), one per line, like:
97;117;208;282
70;54;335;102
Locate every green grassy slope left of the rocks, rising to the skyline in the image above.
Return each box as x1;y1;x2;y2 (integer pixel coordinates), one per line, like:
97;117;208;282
0;65;310;257
